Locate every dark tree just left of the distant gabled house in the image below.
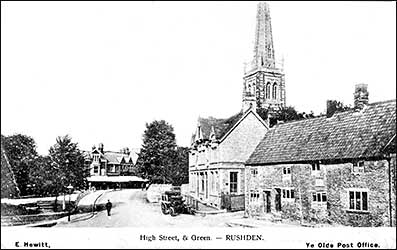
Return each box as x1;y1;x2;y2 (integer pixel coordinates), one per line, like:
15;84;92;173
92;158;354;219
49;135;89;193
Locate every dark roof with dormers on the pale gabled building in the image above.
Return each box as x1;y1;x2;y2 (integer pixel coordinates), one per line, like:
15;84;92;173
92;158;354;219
192;112;243;143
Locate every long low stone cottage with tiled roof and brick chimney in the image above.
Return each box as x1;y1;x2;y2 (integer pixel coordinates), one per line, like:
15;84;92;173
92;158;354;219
245;85;396;226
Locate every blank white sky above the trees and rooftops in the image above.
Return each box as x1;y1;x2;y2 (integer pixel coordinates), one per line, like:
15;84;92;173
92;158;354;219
1;1;396;154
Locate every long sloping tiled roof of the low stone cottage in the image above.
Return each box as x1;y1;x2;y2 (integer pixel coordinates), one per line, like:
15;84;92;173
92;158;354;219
247;100;396;165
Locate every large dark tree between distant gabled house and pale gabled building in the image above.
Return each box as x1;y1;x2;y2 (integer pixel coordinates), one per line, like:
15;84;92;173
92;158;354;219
137;120;184;183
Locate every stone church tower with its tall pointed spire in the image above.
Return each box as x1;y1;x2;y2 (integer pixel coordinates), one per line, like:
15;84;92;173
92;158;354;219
243;3;286;111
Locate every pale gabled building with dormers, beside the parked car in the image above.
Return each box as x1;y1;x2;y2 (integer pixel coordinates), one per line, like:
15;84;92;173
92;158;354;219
189;109;268;211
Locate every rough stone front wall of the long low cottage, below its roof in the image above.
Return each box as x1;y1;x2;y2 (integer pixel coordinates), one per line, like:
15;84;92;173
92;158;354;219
245;158;396;226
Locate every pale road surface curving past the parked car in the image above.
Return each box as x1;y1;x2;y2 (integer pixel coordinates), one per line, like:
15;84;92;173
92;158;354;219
56;189;270;227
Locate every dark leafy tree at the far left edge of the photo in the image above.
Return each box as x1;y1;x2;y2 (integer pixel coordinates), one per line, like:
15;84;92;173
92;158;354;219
1;134;38;196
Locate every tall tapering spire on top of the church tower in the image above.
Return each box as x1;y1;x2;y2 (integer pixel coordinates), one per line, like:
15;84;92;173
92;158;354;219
252;2;275;70
